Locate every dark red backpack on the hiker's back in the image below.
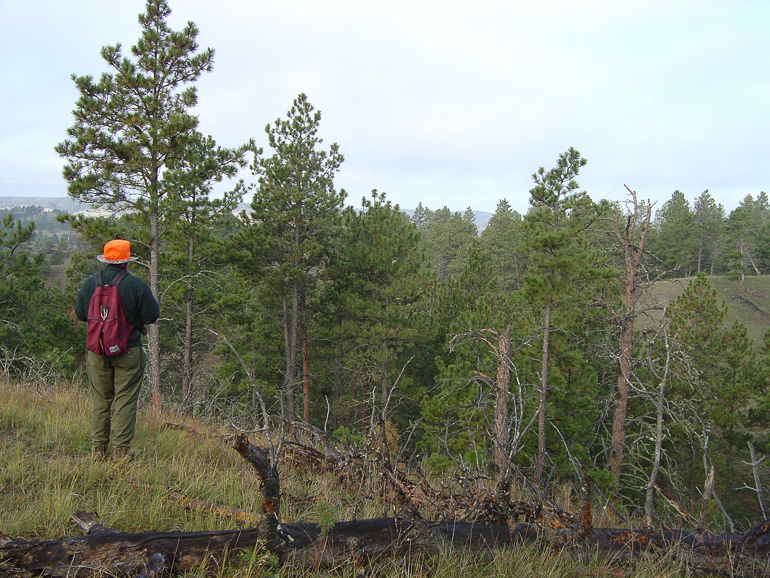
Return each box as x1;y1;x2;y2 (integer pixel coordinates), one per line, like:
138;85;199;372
86;269;133;356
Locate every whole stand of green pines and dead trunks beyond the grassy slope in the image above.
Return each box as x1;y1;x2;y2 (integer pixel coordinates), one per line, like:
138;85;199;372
0;0;770;529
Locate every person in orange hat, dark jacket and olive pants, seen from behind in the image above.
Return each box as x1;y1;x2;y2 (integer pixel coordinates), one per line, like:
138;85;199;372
75;240;160;459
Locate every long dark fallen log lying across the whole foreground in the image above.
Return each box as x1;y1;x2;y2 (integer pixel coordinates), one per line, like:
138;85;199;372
0;518;770;578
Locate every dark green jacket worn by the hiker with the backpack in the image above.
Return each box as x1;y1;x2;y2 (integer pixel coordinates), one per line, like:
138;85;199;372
75;265;160;348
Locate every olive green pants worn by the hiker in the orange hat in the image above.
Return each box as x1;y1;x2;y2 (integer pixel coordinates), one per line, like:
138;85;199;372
86;347;147;450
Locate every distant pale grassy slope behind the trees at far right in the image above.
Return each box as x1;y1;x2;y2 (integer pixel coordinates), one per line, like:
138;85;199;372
639;275;770;349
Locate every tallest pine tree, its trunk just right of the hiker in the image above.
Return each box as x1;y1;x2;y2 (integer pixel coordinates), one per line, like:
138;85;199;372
56;0;244;402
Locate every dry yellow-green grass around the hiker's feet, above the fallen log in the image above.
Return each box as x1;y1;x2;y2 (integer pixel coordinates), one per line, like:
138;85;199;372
0;380;395;538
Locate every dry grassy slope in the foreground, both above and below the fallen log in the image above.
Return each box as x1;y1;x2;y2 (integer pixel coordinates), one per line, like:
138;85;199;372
0;377;687;578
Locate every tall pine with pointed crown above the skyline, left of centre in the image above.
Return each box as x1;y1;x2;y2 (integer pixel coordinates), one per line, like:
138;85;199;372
242;94;346;424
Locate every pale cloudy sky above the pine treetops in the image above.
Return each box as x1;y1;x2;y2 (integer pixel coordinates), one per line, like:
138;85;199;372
0;0;770;213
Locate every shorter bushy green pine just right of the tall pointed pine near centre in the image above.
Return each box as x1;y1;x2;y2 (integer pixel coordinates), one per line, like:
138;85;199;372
325;190;425;439
